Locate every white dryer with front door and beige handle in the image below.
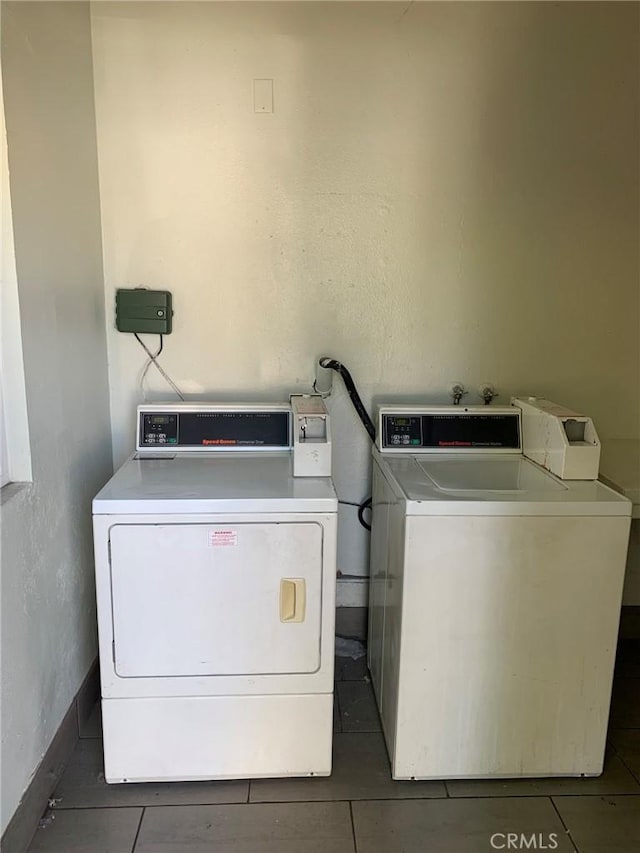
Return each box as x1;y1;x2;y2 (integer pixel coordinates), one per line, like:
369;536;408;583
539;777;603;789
93;398;337;782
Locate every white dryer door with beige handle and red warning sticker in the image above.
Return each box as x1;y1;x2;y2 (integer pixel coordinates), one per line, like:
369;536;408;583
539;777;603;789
110;522;323;678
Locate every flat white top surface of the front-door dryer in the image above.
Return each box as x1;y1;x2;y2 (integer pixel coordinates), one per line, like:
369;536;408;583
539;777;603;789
93;452;338;515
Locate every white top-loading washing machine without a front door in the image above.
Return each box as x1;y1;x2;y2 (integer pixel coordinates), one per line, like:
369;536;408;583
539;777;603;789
368;406;631;779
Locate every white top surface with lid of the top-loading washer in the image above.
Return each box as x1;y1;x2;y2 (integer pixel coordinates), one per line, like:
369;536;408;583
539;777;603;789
374;450;631;516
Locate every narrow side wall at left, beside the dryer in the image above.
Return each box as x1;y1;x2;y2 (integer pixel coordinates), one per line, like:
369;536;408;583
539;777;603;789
0;3;111;831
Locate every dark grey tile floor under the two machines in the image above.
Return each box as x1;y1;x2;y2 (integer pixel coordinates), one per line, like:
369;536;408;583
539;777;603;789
29;640;640;853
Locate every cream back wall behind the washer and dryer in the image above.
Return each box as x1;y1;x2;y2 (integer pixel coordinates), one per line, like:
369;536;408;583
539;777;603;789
92;3;640;574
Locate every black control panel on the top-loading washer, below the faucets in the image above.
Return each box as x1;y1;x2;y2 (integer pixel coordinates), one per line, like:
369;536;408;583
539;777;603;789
377;406;522;453
